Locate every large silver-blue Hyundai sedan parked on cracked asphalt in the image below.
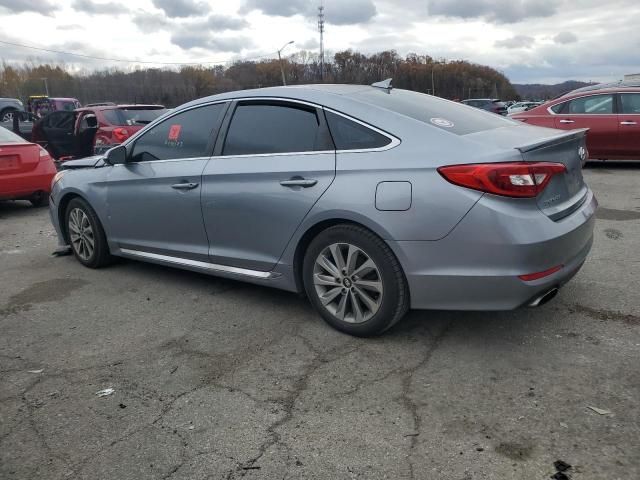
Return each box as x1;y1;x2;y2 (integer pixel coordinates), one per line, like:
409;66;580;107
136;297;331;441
50;84;597;336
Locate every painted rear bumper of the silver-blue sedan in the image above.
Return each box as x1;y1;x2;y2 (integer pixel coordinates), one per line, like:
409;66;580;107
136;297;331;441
389;191;598;310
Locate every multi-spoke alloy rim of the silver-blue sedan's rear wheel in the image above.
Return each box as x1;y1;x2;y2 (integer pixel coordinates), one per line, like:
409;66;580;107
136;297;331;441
313;243;384;323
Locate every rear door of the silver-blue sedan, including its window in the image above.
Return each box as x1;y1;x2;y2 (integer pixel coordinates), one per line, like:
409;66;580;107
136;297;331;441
202;100;336;271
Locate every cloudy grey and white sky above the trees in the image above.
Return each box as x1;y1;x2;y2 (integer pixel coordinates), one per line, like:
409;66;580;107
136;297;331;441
0;0;640;83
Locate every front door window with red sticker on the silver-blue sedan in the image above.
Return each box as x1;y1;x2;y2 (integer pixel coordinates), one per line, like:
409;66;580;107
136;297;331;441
131;103;226;162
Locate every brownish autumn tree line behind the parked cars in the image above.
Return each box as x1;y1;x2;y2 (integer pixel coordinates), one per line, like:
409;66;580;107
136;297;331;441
0;50;518;107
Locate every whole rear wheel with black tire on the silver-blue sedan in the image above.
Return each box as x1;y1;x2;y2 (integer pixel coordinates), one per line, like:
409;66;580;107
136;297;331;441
302;224;409;337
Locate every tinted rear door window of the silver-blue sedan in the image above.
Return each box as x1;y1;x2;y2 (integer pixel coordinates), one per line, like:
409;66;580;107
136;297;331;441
222;103;320;155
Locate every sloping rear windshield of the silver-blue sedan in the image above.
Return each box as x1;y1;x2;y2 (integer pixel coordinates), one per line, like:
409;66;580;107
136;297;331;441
353;88;518;135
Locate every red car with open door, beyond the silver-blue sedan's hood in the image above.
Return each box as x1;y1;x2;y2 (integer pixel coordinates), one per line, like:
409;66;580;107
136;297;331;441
31;105;167;160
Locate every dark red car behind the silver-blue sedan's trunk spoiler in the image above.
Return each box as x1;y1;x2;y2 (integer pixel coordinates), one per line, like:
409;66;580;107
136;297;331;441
511;82;640;160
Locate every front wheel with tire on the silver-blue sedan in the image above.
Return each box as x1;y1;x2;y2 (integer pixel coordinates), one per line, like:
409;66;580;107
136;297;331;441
64;197;113;268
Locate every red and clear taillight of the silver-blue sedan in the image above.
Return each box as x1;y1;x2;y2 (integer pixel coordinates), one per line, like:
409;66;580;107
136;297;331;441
438;162;566;198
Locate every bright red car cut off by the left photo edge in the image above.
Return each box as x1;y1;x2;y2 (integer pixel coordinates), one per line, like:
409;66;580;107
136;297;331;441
0;127;56;207
